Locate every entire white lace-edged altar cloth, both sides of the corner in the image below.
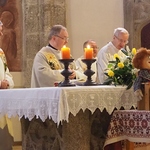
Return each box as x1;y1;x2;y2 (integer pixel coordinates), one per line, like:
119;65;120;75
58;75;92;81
0;86;137;123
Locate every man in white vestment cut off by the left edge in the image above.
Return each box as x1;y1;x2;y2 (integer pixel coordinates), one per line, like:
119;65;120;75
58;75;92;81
0;21;14;150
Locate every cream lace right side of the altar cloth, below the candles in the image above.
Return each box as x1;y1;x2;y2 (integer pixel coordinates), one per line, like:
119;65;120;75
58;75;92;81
58;86;137;121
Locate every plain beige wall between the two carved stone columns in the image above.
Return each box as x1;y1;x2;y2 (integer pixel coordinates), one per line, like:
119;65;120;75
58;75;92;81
66;0;124;58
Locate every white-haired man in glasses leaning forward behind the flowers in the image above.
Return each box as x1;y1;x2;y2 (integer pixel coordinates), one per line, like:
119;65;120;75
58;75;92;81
97;28;129;84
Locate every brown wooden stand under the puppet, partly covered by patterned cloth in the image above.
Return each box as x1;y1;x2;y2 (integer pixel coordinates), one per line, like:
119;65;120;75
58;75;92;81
126;82;150;150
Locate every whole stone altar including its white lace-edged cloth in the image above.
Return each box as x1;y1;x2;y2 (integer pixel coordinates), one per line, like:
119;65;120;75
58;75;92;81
0;85;137;150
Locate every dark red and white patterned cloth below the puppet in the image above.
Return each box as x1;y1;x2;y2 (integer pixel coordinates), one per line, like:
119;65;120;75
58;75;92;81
105;110;150;146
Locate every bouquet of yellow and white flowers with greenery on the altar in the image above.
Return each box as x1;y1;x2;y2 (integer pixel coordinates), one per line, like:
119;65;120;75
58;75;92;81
103;47;136;89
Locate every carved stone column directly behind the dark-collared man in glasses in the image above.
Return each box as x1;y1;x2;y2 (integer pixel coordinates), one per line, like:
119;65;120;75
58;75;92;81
22;0;66;87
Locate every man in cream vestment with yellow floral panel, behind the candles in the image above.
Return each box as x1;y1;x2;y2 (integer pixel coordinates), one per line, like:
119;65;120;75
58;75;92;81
31;25;83;88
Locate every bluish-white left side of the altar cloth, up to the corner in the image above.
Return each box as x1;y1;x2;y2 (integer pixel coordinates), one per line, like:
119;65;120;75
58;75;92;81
0;88;61;122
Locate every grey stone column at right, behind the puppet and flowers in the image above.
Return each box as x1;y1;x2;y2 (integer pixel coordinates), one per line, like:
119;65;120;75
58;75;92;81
124;0;150;48
